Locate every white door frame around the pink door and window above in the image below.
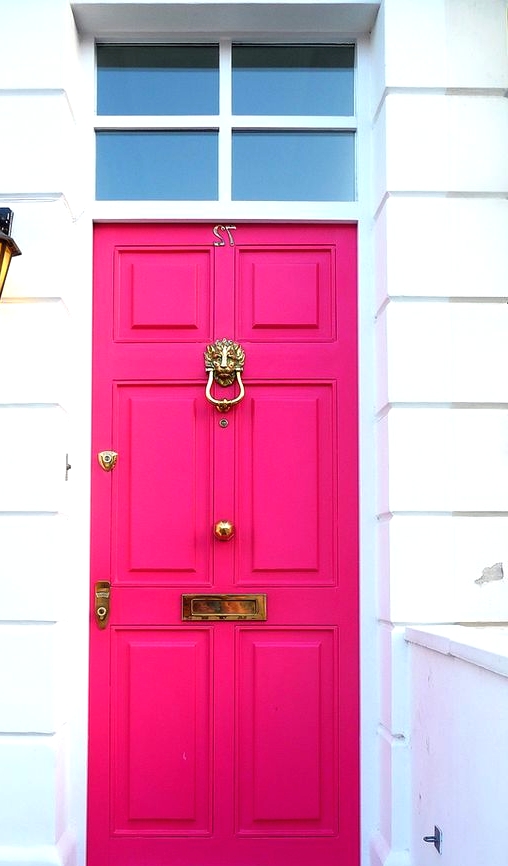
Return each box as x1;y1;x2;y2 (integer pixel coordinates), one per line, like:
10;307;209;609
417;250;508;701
76;16;378;864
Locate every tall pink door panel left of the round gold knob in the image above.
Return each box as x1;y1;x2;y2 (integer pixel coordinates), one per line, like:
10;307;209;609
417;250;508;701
113;383;212;585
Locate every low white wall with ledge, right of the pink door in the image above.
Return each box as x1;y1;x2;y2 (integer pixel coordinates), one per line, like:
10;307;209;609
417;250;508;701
407;626;508;866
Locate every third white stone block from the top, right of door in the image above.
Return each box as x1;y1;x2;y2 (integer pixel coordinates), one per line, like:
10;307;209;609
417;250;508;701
376;196;508;306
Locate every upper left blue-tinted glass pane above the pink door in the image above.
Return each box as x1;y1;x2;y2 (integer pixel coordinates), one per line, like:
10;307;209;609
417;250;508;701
97;45;219;115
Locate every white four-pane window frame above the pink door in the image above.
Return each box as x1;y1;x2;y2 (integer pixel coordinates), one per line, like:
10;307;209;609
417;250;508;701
83;33;370;222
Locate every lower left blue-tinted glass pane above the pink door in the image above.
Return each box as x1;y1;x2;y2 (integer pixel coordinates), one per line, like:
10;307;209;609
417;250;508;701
97;131;218;201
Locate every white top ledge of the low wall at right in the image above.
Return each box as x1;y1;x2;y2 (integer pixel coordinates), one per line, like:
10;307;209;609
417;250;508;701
405;625;508;677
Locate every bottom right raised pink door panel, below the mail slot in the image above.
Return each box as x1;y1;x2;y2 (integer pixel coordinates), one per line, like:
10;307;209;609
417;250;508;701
237;628;337;836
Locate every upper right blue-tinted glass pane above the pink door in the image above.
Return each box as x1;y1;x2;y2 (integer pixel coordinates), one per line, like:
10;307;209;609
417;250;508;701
233;45;354;116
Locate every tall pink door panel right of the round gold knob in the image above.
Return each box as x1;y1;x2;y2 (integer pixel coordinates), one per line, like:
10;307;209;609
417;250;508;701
237;383;336;587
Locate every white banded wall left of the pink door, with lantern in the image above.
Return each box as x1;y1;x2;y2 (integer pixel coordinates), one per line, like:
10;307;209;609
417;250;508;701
0;0;92;866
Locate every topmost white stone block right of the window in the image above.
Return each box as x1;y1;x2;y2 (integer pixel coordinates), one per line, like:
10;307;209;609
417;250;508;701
384;0;508;88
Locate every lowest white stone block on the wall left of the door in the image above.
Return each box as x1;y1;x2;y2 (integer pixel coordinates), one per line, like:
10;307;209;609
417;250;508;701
0;737;61;844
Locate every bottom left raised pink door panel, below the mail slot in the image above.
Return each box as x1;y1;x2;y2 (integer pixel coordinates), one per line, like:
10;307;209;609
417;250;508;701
111;629;213;836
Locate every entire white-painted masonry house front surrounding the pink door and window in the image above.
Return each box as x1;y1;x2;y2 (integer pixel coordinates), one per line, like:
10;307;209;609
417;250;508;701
0;0;508;866
